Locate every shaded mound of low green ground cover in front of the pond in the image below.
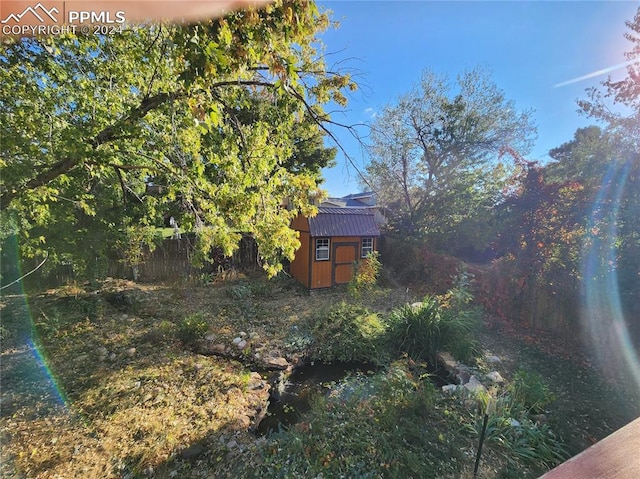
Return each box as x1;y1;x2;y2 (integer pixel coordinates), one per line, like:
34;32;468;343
250;362;463;478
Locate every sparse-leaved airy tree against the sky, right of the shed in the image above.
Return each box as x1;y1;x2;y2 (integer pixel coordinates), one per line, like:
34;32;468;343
366;69;535;248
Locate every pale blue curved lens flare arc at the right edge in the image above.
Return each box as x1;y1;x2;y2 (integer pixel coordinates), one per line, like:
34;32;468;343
582;162;640;396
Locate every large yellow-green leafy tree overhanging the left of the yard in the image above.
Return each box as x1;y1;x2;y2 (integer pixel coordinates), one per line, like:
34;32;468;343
0;0;355;273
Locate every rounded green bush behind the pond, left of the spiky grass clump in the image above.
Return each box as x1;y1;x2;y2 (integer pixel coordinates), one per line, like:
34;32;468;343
312;302;388;364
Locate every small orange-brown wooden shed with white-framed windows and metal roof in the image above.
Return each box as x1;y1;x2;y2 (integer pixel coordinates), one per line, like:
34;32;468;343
290;207;380;289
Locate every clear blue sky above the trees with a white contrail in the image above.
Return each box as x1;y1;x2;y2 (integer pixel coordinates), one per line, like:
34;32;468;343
319;0;640;196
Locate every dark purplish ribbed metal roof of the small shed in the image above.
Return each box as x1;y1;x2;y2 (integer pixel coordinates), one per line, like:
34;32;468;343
309;207;380;237
